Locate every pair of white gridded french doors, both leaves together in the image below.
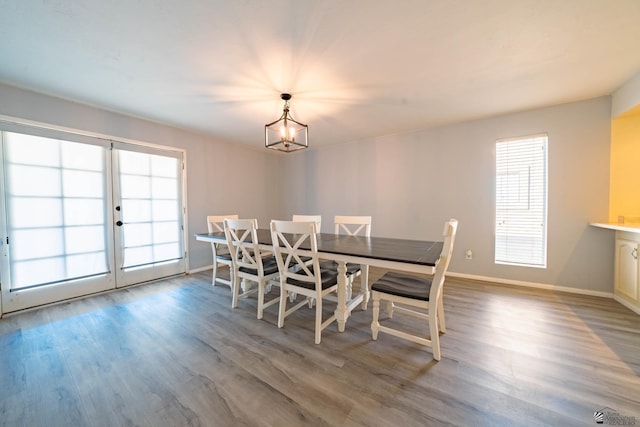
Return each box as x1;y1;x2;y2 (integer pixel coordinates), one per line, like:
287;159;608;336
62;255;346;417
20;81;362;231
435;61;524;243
0;130;185;312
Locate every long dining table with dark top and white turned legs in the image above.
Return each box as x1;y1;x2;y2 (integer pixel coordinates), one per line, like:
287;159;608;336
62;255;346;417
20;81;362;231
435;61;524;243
195;228;443;332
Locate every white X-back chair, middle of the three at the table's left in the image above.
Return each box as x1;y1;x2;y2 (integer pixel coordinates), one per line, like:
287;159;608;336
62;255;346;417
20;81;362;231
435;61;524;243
224;218;280;319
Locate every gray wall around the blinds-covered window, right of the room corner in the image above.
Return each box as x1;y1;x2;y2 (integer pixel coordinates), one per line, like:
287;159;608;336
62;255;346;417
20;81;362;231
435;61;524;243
283;97;614;292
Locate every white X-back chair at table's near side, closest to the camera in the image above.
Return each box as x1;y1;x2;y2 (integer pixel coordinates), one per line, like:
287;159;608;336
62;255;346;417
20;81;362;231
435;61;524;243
271;220;338;344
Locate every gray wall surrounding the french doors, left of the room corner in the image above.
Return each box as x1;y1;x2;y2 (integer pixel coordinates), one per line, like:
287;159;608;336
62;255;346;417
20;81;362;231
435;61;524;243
0;84;280;270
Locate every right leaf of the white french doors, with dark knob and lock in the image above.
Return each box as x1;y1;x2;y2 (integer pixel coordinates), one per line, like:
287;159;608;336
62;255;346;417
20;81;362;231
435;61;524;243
114;149;185;286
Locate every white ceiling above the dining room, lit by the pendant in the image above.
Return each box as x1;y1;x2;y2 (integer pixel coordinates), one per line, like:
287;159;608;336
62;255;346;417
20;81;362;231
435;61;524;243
0;0;640;147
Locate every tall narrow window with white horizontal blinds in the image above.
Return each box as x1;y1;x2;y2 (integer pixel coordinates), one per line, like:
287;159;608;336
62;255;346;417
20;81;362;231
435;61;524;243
495;134;547;268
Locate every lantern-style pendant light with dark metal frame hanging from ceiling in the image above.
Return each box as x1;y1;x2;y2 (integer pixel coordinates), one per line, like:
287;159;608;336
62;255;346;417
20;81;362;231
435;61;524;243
264;93;309;153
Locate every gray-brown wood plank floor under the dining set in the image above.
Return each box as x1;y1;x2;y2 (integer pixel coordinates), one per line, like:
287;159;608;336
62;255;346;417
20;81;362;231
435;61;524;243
0;269;640;427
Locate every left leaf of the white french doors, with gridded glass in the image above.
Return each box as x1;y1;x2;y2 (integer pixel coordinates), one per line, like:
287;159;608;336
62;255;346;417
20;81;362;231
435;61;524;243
2;132;114;311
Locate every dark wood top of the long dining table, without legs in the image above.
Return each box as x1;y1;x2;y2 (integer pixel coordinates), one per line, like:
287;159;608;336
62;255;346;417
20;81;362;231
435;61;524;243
196;228;443;267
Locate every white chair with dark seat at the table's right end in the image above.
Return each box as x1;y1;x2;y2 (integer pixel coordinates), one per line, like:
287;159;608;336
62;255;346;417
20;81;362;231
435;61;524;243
371;219;458;360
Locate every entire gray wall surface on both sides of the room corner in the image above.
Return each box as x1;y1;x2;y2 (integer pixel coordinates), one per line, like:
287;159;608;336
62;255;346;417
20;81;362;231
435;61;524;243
0;84;613;292
